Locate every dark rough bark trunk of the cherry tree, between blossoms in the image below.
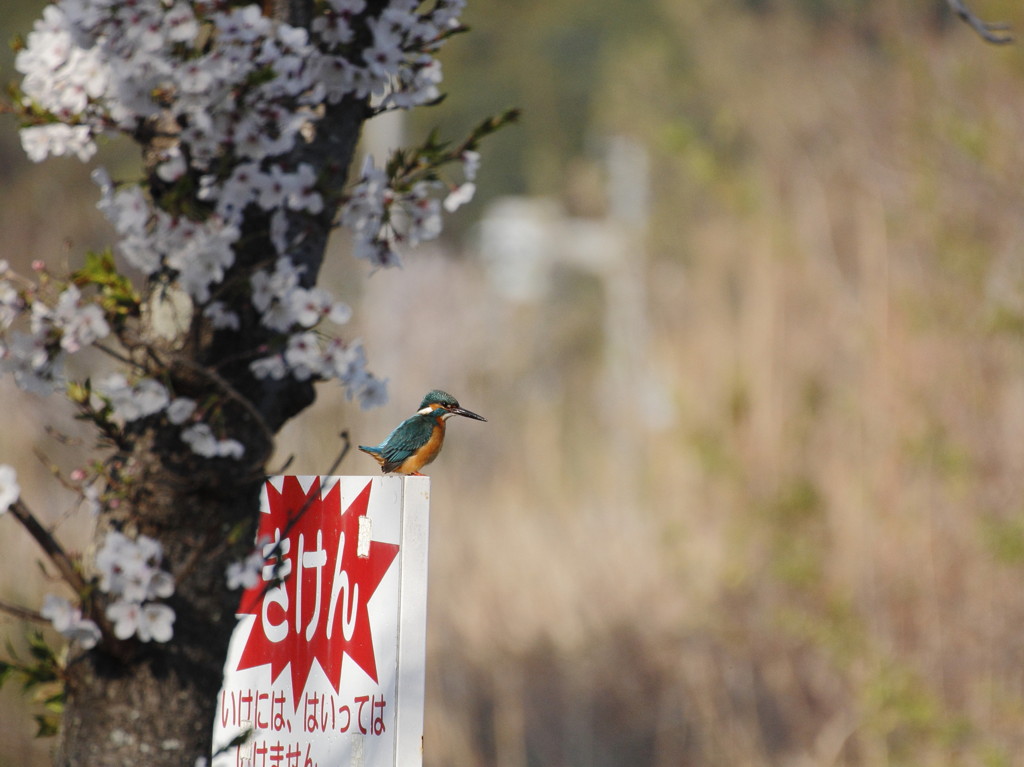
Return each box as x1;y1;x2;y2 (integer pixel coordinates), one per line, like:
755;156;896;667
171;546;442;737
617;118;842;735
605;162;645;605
56;43;369;767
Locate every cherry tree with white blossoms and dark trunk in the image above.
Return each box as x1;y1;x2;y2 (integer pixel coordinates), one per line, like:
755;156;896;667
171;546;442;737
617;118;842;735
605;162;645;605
0;0;515;767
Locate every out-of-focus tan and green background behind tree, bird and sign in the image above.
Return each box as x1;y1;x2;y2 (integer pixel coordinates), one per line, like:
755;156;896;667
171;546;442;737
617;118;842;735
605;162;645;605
6;0;1024;767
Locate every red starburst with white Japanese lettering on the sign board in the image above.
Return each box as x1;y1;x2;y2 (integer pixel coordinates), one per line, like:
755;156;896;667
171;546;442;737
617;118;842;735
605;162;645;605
238;476;398;706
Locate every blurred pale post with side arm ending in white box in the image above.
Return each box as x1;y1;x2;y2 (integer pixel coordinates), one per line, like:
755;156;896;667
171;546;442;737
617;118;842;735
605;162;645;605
480;136;673;484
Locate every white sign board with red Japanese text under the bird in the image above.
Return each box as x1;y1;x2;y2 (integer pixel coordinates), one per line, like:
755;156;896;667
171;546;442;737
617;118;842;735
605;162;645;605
212;475;430;767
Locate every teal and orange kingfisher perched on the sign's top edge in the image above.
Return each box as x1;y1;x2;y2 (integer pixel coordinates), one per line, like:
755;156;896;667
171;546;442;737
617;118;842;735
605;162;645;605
359;389;487;476
